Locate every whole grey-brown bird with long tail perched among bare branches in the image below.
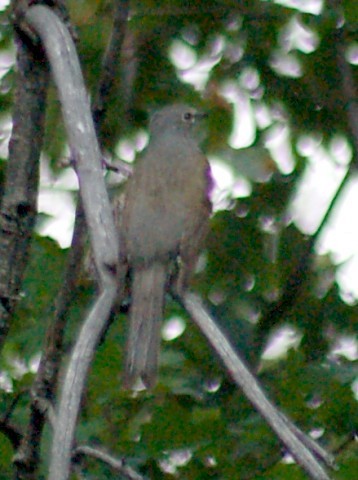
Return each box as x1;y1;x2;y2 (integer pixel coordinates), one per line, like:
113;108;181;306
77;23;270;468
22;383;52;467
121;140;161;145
120;104;212;389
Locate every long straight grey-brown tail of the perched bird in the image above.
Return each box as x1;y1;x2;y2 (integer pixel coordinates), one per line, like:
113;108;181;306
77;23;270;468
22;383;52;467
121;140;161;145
123;263;167;388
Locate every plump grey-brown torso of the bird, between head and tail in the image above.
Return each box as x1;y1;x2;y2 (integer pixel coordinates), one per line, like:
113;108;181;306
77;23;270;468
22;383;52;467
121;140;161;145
123;140;207;263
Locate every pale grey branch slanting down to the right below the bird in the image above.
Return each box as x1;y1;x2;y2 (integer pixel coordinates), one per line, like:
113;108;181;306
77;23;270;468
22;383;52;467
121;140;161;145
181;293;333;480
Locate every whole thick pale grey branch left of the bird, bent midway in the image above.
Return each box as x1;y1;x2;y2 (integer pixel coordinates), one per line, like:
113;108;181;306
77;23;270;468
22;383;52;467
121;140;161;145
25;6;119;480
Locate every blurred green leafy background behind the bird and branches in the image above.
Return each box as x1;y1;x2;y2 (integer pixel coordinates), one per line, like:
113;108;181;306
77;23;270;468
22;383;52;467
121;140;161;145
0;0;358;480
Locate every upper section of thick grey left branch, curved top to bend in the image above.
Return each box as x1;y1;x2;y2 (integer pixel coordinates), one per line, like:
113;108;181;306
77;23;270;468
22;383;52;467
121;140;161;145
26;5;118;276
